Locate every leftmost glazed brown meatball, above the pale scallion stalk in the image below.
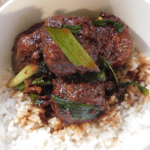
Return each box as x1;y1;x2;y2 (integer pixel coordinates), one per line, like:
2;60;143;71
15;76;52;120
12;23;44;73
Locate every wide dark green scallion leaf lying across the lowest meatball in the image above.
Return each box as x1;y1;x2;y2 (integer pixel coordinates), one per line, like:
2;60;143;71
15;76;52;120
51;94;105;120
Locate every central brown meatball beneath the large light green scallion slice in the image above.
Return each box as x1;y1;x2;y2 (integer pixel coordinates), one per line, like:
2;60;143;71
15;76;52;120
42;15;98;76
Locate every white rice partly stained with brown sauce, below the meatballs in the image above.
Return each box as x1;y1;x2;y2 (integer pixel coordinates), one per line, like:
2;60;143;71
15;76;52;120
0;51;150;150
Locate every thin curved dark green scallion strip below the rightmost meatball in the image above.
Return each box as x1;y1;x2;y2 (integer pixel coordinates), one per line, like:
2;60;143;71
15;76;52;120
97;56;118;83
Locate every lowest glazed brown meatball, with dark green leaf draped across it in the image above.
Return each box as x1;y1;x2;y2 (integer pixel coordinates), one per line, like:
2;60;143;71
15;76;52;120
51;77;106;124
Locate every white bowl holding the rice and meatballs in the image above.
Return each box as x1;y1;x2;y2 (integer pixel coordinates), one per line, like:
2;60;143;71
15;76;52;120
0;0;150;86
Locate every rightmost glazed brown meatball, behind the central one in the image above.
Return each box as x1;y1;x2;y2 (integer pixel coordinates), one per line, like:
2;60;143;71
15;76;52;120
96;13;133;68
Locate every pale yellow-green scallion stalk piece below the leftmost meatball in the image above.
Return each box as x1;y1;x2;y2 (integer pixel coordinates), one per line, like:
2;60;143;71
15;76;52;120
9;64;39;88
